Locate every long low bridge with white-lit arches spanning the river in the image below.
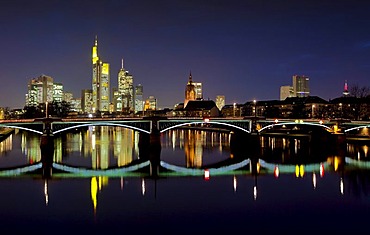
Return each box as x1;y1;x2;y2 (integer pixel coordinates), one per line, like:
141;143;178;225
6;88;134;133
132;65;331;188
0;117;370;134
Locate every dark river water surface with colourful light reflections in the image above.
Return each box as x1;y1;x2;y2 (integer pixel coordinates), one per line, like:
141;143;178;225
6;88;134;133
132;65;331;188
0;127;370;234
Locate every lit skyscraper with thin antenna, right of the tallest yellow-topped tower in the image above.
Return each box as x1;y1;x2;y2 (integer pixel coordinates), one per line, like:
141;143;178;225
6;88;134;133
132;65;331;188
117;59;135;114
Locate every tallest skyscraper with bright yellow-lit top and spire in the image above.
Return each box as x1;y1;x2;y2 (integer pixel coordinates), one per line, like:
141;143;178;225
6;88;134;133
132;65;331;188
91;37;110;112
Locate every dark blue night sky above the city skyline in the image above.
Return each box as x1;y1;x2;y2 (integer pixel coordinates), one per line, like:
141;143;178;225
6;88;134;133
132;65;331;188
0;0;370;108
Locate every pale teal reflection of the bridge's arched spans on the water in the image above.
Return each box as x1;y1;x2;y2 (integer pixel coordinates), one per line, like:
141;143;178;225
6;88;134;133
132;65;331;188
0;157;370;178
